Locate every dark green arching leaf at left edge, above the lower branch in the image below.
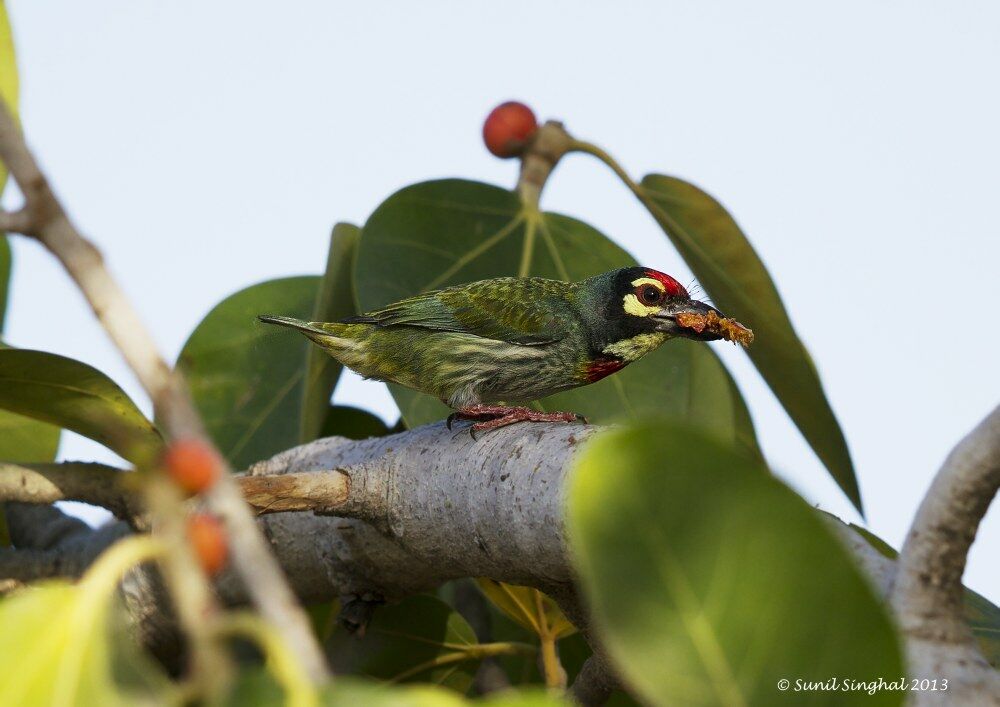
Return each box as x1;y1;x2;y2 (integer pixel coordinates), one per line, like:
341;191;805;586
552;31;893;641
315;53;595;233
0;349;161;461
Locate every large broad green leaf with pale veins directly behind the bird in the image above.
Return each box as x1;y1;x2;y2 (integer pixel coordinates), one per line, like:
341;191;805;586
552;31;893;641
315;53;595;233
354;179;755;450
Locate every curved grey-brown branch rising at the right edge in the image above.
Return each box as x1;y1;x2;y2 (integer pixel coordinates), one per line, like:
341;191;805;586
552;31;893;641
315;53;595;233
891;407;1000;705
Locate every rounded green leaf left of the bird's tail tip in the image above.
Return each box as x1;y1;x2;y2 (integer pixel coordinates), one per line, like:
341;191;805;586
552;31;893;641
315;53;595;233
177;276;320;469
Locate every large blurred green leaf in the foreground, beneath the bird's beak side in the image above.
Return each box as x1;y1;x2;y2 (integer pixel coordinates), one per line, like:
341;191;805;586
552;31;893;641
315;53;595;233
568;422;904;705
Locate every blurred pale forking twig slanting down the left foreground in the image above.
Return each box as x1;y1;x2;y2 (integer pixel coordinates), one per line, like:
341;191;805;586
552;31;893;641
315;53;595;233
0;101;328;683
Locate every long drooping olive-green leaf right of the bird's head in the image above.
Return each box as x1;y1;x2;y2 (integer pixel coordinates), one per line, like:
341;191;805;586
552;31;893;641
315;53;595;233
638;174;863;513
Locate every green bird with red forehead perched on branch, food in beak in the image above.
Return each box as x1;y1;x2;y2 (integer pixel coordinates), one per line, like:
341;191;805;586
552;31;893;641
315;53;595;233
258;266;749;436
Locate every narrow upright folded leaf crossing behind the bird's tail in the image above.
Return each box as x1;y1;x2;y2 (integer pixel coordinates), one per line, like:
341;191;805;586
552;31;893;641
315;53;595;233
299;223;361;442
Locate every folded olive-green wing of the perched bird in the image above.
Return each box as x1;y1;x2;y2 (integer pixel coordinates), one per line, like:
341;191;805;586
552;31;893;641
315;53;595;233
344;277;574;346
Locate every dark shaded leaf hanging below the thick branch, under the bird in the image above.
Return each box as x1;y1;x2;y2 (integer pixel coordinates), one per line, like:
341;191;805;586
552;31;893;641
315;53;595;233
326;595;478;693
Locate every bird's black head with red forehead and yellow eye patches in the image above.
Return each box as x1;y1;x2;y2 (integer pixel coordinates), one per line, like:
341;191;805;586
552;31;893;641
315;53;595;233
584;267;723;350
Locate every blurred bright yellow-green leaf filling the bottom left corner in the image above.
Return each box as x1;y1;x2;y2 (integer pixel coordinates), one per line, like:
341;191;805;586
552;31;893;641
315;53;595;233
0;537;177;707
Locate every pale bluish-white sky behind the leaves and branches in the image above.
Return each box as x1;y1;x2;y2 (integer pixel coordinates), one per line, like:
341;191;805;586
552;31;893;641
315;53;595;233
0;0;1000;602
